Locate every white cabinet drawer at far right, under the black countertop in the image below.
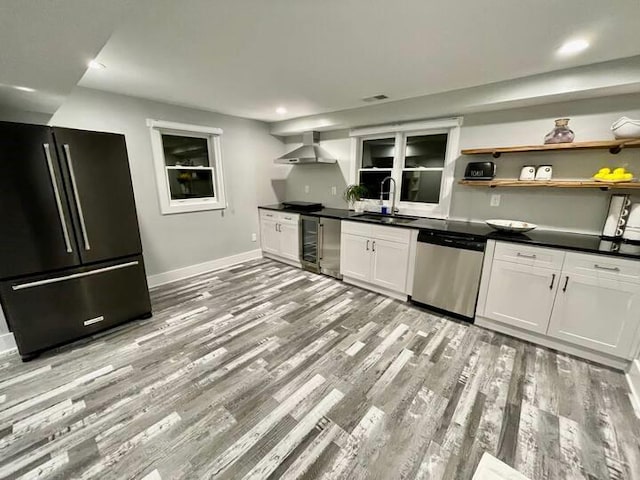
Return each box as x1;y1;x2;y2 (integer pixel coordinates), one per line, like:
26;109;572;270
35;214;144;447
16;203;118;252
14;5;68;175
563;252;640;284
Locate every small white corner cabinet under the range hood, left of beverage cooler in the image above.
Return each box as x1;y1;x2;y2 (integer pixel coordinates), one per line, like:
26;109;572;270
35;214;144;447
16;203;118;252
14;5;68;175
260;210;300;263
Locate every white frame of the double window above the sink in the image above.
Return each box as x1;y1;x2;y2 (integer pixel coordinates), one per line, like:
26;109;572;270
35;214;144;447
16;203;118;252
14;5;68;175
350;117;462;218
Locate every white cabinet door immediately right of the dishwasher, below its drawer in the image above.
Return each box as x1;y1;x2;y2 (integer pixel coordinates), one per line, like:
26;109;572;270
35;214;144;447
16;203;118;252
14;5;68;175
485;260;560;333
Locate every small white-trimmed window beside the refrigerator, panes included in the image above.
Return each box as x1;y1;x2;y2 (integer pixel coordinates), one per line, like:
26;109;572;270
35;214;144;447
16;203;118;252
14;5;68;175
147;120;226;214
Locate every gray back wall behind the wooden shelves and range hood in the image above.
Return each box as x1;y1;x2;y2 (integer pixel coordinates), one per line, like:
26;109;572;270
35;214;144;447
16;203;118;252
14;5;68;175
281;94;640;233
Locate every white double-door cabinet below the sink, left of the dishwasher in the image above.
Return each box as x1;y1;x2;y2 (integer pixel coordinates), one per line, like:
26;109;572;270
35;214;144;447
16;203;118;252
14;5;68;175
340;222;411;294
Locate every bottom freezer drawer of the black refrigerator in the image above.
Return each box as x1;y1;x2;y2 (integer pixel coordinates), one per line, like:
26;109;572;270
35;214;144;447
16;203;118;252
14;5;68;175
0;256;151;357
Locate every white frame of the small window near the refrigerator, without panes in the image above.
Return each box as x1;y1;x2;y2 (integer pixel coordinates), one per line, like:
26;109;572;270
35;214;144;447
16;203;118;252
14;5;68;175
147;119;227;215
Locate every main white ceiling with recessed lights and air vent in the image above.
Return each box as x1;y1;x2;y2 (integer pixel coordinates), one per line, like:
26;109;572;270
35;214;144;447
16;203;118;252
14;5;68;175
0;0;640;121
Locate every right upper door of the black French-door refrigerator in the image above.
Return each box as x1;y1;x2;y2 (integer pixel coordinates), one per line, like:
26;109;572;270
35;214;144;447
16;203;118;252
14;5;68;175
53;128;142;263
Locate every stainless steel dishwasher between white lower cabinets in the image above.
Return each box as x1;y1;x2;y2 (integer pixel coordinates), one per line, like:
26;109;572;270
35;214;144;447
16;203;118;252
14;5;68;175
411;231;487;321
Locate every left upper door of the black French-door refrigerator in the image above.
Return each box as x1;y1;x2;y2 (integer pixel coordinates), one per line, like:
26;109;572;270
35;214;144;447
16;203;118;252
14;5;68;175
0;122;80;278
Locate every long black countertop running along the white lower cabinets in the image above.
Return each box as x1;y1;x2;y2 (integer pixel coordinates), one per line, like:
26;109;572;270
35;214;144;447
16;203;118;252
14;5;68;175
260;205;640;260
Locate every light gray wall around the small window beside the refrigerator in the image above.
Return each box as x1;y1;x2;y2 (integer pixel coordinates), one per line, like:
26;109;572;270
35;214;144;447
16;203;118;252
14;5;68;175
51;88;284;275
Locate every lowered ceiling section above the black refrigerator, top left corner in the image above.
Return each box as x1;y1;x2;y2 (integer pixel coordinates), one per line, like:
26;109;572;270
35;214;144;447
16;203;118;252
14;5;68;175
0;0;126;113
